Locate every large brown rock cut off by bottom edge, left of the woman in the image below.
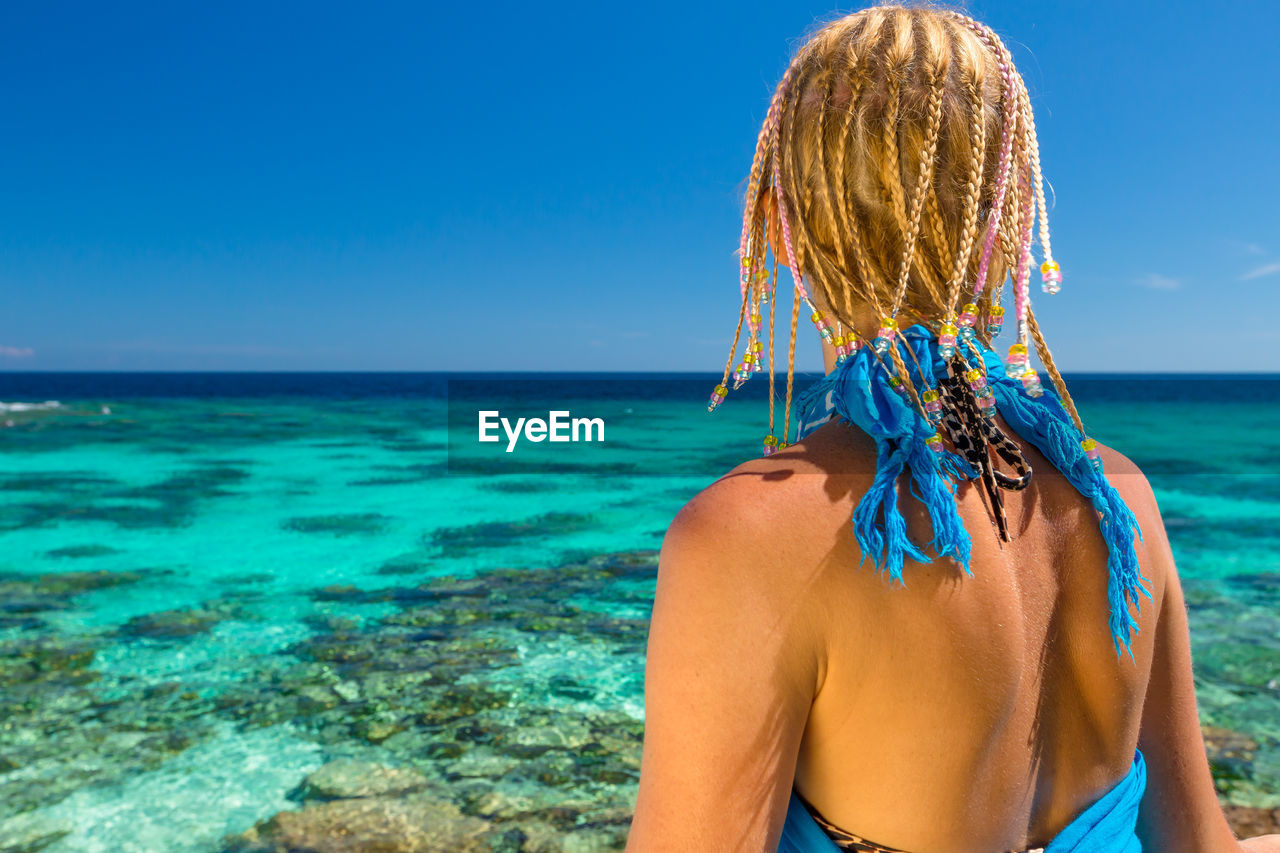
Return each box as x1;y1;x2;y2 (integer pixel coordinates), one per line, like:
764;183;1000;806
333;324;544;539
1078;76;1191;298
225;795;490;853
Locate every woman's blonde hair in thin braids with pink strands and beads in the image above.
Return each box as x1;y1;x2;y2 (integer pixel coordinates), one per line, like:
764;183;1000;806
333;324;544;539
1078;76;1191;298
724;5;1084;444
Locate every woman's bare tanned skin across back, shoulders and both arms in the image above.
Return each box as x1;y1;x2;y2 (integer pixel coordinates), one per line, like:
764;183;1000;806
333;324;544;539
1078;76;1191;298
627;404;1249;853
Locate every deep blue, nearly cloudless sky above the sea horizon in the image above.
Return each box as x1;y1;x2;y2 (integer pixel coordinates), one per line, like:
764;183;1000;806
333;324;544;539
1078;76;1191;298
0;0;1280;371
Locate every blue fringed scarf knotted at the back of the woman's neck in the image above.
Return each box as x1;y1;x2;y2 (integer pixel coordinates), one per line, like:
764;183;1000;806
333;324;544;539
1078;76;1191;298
795;324;1151;660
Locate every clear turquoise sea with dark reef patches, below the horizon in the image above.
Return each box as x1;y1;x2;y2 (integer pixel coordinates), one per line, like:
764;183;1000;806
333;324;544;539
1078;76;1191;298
0;374;1280;853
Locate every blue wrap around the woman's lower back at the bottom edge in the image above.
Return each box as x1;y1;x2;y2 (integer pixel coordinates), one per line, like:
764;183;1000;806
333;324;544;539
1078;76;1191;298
777;749;1147;853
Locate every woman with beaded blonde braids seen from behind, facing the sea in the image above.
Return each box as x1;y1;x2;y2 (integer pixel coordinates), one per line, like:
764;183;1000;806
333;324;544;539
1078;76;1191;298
627;6;1280;853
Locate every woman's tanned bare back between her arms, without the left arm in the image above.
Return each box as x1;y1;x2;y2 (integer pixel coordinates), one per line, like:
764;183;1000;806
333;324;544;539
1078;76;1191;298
776;414;1170;852
